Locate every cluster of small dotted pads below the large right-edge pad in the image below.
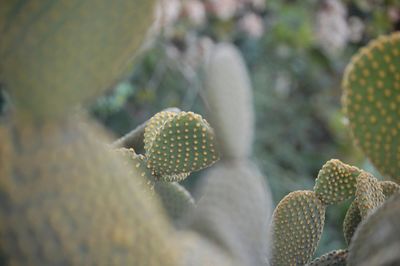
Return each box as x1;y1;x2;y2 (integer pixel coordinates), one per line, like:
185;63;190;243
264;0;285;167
271;159;400;265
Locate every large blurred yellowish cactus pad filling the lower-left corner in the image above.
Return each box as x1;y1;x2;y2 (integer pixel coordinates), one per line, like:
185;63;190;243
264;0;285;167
0;117;179;266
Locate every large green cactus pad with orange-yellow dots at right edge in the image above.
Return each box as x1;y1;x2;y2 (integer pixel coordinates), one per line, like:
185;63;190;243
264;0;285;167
343;32;400;182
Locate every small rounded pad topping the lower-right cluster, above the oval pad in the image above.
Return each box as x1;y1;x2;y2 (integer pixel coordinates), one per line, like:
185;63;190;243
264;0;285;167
314;159;360;205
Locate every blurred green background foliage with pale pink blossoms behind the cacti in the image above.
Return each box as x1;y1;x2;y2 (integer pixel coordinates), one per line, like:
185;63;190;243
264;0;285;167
91;0;400;256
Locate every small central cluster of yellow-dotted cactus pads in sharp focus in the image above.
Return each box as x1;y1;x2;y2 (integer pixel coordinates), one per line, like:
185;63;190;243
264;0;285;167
117;110;219;223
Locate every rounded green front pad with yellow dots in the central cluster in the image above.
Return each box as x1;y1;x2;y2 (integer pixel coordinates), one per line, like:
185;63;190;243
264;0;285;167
146;112;219;180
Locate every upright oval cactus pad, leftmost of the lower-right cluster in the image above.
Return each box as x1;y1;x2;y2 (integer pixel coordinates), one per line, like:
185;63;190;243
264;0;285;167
271;191;325;265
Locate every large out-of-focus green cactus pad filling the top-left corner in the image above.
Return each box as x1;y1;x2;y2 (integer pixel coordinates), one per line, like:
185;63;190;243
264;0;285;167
0;0;154;117
